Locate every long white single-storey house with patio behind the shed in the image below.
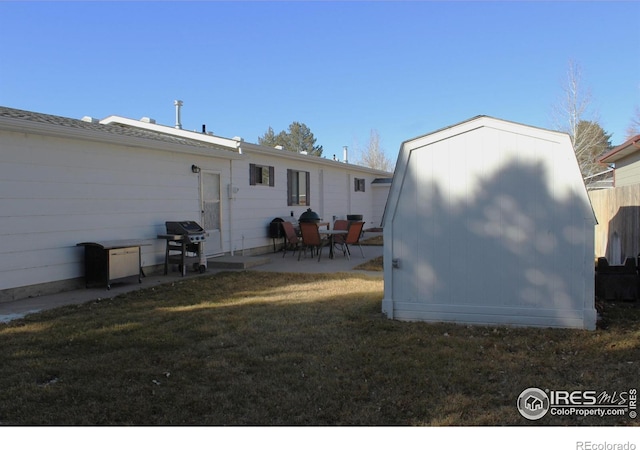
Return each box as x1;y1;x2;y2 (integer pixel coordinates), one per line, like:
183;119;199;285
0;107;391;301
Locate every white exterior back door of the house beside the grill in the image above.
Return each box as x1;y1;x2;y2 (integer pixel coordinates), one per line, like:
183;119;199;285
200;171;223;256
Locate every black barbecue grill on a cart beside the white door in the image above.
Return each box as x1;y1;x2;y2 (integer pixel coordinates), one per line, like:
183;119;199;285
158;220;207;276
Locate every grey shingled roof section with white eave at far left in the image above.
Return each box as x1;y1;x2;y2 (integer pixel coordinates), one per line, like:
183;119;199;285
0;106;237;155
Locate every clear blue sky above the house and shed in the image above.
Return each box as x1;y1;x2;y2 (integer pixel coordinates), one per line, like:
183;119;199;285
0;0;640;161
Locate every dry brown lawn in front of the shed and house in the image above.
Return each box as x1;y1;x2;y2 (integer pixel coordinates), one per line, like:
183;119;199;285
0;272;640;425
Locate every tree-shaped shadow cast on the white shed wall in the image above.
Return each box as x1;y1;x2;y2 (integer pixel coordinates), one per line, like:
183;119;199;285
392;160;595;327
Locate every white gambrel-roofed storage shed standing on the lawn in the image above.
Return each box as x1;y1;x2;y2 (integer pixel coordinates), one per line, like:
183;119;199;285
382;116;596;329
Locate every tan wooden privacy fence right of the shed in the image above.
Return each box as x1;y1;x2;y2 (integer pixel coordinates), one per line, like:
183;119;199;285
589;184;640;264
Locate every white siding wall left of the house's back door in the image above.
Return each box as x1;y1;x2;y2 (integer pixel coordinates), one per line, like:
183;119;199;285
0;133;229;289
